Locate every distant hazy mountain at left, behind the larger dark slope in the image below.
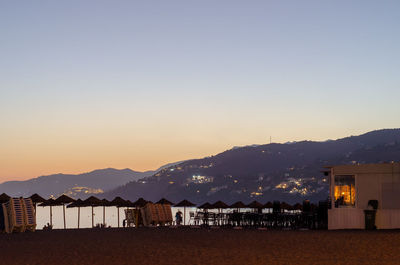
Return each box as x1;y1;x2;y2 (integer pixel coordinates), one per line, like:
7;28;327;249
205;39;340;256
0;168;155;198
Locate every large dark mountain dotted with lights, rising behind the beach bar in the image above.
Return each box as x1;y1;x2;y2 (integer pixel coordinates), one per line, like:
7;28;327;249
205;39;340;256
104;129;400;203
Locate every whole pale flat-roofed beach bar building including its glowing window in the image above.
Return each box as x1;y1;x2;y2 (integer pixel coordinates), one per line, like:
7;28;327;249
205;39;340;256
328;162;400;229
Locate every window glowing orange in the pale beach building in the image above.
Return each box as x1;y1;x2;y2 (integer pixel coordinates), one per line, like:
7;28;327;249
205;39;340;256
335;175;356;207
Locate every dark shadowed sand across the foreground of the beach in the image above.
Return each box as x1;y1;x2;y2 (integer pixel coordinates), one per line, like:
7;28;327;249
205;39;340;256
0;228;400;265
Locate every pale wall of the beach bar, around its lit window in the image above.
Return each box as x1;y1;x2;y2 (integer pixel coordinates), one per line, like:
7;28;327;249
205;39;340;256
328;163;400;229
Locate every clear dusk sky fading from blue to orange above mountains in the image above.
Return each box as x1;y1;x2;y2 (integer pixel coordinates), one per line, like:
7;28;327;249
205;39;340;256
0;0;400;179
